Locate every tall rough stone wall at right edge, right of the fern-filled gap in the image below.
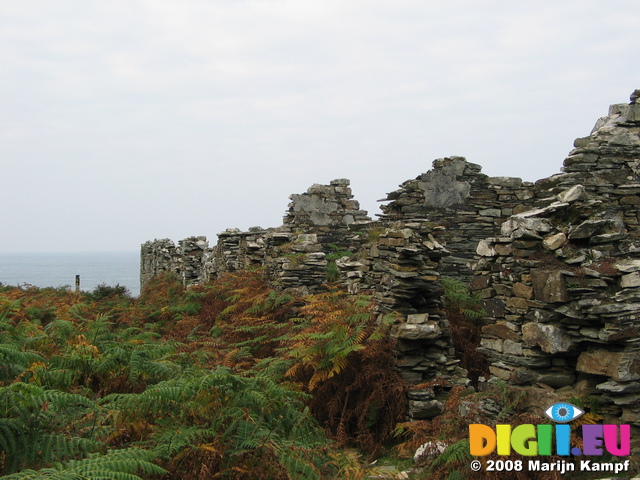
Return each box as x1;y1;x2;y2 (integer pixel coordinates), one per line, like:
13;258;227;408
472;92;640;425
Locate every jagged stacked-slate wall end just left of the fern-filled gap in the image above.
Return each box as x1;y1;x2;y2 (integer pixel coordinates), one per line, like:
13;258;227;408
344;222;467;392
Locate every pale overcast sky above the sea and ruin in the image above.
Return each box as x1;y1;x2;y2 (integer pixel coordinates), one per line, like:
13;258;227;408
0;0;640;253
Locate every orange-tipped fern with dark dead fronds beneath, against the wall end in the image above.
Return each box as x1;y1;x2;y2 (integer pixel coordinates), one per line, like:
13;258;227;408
280;290;406;452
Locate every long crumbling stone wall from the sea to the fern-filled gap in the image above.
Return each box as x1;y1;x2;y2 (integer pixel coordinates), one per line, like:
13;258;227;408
141;179;468;419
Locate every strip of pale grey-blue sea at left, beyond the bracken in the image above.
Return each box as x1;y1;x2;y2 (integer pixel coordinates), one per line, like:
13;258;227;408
0;252;140;297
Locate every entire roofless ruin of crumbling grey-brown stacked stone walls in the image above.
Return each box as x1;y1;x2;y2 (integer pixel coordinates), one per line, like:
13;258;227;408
140;90;640;428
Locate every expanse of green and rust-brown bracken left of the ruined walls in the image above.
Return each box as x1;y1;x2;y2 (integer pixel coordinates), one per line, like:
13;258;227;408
0;273;405;480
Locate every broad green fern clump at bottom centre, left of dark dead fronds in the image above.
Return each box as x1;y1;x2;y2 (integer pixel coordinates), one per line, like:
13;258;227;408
103;369;325;476
